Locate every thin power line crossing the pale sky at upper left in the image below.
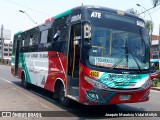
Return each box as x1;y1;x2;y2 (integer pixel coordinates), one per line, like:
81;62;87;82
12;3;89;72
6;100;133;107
5;0;51;16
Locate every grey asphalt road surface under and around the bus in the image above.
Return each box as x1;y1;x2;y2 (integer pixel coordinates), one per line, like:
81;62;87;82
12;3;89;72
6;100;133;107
0;65;160;120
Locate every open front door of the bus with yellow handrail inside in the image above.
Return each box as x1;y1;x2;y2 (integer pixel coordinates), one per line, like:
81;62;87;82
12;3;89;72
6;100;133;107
68;23;82;96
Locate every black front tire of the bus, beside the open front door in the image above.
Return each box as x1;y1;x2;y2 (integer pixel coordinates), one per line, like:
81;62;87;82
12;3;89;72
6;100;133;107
58;84;70;107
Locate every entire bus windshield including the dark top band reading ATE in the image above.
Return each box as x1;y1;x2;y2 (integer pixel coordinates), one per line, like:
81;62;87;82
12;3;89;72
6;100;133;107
88;10;149;70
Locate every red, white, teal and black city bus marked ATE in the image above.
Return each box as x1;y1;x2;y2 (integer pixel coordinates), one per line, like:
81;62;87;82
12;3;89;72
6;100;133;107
11;5;151;106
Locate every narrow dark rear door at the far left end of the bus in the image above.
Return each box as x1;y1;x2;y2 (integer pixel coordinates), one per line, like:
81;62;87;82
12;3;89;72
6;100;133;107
15;39;20;76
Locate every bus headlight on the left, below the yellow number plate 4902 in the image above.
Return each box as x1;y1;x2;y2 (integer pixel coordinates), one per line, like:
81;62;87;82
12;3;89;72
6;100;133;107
84;76;107;89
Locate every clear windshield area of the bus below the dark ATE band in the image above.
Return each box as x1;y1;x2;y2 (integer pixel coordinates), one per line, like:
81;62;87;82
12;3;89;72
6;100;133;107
89;27;149;70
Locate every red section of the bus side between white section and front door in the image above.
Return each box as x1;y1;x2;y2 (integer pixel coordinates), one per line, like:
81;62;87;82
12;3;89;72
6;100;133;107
44;51;67;92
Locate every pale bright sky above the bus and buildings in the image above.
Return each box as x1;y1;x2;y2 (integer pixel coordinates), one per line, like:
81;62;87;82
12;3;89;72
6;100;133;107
0;0;160;39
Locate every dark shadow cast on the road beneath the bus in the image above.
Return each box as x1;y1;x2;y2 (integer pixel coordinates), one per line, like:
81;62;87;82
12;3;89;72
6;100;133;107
12;81;146;119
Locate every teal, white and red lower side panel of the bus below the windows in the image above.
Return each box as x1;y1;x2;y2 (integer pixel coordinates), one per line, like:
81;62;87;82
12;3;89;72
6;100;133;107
18;52;67;92
